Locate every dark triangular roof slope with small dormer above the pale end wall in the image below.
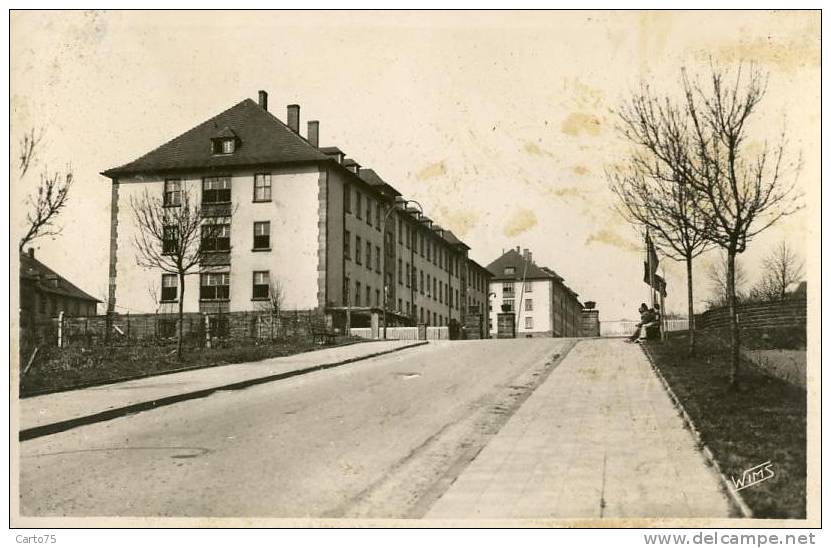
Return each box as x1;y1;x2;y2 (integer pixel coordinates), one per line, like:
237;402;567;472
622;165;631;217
103;99;333;178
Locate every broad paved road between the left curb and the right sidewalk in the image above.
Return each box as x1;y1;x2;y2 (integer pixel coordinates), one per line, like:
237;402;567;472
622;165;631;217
20;339;573;517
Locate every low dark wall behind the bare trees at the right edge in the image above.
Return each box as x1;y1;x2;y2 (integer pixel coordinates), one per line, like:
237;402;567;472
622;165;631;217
695;299;808;329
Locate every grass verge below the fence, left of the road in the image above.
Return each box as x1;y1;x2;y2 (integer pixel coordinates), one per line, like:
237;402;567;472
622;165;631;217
20;337;364;397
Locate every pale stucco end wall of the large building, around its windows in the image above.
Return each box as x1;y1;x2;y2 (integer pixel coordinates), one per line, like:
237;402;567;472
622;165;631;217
116;167;319;313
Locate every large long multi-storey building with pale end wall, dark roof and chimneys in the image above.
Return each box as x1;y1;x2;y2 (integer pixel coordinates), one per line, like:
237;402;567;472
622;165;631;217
103;91;486;327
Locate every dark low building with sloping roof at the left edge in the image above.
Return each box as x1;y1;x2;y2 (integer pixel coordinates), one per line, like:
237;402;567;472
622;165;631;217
20;248;101;321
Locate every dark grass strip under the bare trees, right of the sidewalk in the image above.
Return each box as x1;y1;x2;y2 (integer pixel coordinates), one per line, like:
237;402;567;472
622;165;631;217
647;332;807;518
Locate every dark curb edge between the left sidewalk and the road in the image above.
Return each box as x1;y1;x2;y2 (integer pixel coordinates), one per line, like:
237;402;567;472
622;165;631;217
18;341;429;442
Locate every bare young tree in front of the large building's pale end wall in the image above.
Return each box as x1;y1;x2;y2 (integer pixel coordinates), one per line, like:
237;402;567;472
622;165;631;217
130;188;221;359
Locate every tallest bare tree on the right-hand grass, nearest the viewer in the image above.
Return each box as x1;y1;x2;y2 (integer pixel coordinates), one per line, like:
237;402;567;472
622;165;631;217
680;66;801;389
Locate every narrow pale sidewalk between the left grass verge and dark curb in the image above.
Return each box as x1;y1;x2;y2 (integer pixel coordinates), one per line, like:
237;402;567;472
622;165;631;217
19;341;423;439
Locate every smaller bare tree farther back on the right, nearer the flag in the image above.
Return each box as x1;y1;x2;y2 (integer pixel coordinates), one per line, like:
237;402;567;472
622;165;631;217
606;139;711;355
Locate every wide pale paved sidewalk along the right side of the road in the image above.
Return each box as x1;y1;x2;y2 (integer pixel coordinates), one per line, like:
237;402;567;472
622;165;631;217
425;339;731;519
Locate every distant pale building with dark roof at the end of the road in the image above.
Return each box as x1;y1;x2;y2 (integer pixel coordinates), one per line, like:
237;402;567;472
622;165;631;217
488;247;583;337
